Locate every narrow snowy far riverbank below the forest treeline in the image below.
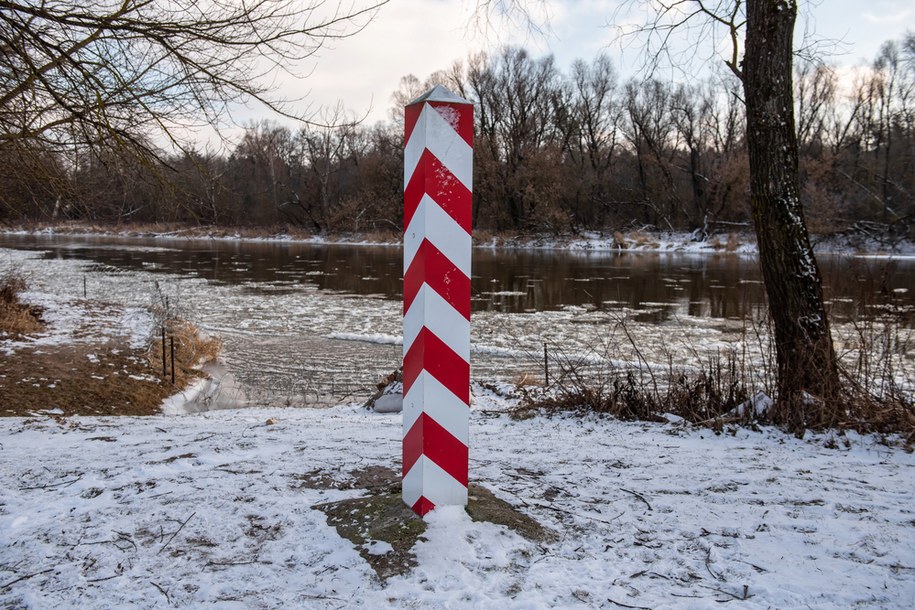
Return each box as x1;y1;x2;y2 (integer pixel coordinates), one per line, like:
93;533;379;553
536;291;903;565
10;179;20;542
7;222;915;257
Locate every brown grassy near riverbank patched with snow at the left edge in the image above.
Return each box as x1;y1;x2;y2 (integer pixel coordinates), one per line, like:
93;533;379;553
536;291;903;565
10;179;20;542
0;268;219;417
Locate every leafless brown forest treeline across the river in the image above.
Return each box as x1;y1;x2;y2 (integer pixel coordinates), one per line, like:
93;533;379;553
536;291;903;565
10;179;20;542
0;34;915;240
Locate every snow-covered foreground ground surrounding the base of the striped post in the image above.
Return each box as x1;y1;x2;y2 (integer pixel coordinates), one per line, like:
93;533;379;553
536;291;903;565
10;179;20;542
0;400;915;609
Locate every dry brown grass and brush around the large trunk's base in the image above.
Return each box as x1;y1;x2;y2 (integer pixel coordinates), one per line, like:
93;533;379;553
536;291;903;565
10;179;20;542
513;319;915;448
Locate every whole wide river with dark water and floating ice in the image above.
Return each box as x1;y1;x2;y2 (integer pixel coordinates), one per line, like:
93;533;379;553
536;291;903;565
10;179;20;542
0;234;915;404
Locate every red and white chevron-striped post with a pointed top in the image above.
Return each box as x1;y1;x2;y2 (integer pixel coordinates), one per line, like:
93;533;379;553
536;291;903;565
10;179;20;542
403;86;473;515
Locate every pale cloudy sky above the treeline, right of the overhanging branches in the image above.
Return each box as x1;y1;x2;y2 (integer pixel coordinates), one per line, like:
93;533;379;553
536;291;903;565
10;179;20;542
227;0;915;132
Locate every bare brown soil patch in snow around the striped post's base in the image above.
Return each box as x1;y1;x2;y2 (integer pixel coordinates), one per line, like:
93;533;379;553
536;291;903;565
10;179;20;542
308;466;556;581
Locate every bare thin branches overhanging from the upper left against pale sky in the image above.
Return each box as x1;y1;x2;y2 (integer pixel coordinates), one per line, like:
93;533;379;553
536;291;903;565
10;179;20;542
0;0;387;159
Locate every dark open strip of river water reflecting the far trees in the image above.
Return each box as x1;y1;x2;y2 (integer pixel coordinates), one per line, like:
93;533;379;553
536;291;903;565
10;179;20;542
0;235;915;325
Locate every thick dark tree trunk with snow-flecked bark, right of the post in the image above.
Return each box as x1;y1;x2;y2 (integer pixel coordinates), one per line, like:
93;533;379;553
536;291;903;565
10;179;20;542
743;0;839;430
